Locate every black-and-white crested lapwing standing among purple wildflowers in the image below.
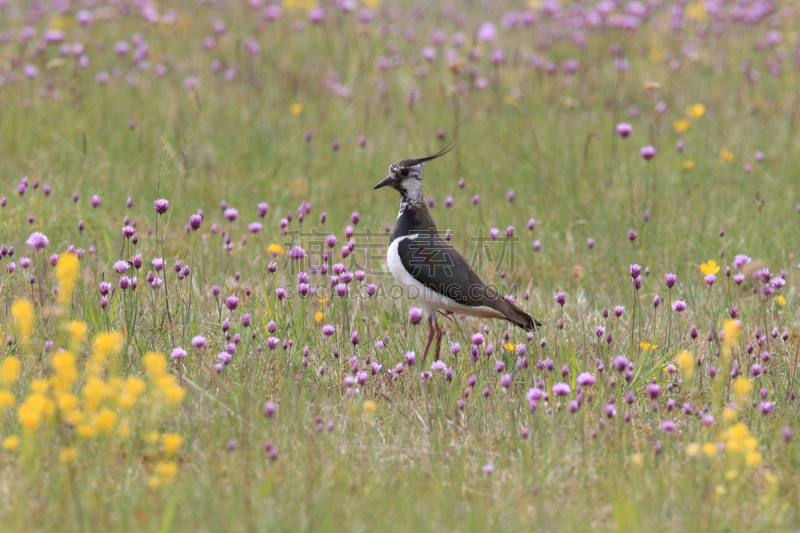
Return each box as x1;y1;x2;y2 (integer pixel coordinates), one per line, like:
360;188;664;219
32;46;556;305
374;145;541;361
